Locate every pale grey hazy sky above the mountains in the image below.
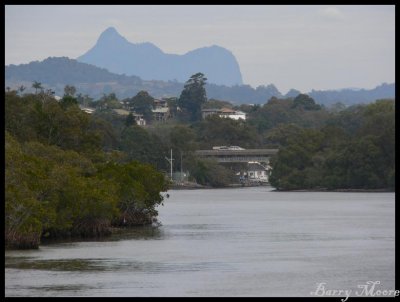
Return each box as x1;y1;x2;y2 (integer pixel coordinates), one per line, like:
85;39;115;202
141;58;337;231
5;5;395;93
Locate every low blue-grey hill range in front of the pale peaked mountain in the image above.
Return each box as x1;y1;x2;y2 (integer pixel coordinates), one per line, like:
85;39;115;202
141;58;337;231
5;57;395;106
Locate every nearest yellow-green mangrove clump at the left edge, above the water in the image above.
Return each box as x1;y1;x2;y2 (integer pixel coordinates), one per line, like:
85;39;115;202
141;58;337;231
5;134;118;248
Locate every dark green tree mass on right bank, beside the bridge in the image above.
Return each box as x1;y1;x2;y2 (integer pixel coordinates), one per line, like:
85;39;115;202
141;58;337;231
270;100;395;190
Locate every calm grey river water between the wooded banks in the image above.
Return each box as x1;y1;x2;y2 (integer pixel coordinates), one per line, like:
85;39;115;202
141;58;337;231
5;187;395;297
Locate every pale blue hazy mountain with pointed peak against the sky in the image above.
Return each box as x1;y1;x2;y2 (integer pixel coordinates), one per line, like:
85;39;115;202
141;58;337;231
77;27;243;86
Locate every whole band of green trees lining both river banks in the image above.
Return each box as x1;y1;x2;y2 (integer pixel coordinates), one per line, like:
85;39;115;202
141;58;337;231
5;73;395;249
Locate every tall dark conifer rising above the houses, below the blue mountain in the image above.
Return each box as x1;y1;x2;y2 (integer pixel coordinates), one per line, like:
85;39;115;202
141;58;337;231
178;72;207;122
